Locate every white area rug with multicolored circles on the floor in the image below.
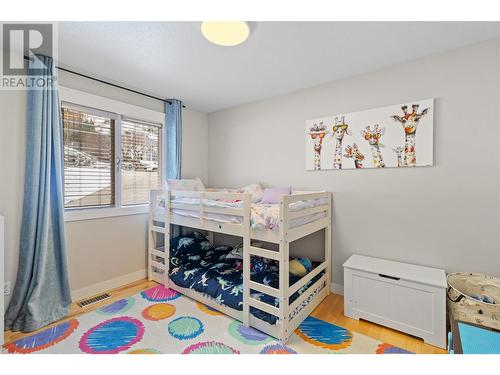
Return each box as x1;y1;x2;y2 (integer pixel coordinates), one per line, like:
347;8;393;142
4;285;414;354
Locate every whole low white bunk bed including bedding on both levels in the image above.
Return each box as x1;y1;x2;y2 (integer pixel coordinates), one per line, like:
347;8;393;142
148;190;331;343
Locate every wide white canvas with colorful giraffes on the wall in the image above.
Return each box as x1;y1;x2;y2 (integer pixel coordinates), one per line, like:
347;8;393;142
305;99;434;171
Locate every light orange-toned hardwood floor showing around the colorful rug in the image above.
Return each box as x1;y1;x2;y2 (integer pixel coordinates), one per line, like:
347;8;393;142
5;280;446;354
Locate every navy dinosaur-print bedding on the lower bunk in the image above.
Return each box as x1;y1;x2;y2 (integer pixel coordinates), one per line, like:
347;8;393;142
170;232;322;324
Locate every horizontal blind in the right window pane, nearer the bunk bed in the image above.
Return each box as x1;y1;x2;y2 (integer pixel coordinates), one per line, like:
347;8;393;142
120;118;161;206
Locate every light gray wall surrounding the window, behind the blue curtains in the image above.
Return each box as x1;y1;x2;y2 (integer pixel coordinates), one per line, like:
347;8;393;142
0;70;208;306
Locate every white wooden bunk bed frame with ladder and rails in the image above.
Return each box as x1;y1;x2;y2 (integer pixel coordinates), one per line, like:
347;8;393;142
148;190;331;343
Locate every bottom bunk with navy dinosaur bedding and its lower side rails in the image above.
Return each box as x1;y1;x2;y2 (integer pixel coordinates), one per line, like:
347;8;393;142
155;232;328;336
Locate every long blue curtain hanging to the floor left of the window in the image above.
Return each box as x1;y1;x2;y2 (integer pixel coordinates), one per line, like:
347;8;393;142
5;56;71;332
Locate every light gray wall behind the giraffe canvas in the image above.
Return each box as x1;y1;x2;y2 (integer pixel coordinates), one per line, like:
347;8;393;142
209;40;500;290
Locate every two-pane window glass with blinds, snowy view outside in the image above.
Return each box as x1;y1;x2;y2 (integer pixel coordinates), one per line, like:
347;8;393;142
62;102;161;212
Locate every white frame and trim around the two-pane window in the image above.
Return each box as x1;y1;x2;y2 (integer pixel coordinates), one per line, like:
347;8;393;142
59;86;166;222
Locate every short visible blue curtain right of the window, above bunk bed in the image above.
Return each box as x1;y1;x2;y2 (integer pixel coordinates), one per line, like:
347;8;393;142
163;99;182;178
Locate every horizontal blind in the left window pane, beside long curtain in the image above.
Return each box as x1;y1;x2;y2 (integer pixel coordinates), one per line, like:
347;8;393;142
62;103;115;208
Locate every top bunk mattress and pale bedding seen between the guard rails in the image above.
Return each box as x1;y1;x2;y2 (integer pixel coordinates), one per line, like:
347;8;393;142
156;197;328;230
